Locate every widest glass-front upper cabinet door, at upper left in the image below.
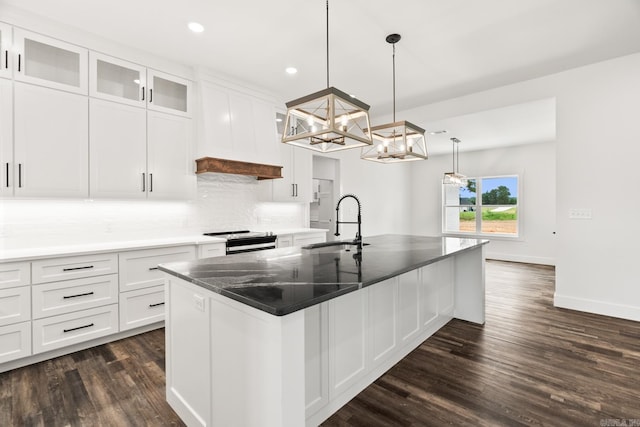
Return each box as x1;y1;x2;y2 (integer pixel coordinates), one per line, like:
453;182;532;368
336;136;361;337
13;28;88;95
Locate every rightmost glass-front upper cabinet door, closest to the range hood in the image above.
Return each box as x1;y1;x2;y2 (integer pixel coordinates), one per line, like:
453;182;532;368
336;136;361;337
147;69;191;117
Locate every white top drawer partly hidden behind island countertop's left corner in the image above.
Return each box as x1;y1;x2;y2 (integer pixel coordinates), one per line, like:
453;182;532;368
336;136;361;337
118;245;196;292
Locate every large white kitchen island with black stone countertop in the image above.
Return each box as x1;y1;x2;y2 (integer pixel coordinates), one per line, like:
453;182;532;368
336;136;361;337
160;235;487;426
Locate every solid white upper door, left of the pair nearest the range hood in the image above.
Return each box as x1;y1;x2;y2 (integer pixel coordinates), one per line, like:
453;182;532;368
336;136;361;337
89;99;147;199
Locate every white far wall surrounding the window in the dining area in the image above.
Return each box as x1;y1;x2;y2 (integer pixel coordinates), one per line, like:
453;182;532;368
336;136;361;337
411;142;556;264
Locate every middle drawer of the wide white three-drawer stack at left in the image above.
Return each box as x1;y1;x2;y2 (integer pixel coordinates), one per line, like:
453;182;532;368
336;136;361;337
32;274;118;319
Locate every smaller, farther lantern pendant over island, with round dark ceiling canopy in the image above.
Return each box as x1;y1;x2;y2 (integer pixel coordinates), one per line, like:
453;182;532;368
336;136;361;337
360;34;427;163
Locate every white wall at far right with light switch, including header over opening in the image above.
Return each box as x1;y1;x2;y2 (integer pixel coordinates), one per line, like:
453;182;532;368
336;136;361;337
400;54;640;320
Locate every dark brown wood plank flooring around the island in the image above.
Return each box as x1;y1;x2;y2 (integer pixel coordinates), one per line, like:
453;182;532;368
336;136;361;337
0;261;640;427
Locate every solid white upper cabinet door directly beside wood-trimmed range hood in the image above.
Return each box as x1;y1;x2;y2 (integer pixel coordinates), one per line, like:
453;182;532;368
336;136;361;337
146;111;196;199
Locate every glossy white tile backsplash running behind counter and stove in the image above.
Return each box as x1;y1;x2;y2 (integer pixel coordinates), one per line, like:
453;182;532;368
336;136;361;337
0;174;309;249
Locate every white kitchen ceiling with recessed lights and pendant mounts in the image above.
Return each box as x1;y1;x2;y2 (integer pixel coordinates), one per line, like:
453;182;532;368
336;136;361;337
0;0;640;155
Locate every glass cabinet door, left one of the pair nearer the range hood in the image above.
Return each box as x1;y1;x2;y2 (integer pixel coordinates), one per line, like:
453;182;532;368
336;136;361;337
89;52;147;107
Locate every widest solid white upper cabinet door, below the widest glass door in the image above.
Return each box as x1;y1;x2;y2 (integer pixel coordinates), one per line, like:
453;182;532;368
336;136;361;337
13;82;89;198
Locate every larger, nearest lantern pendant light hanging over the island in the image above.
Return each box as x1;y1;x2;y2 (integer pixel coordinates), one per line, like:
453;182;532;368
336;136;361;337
282;0;372;153
